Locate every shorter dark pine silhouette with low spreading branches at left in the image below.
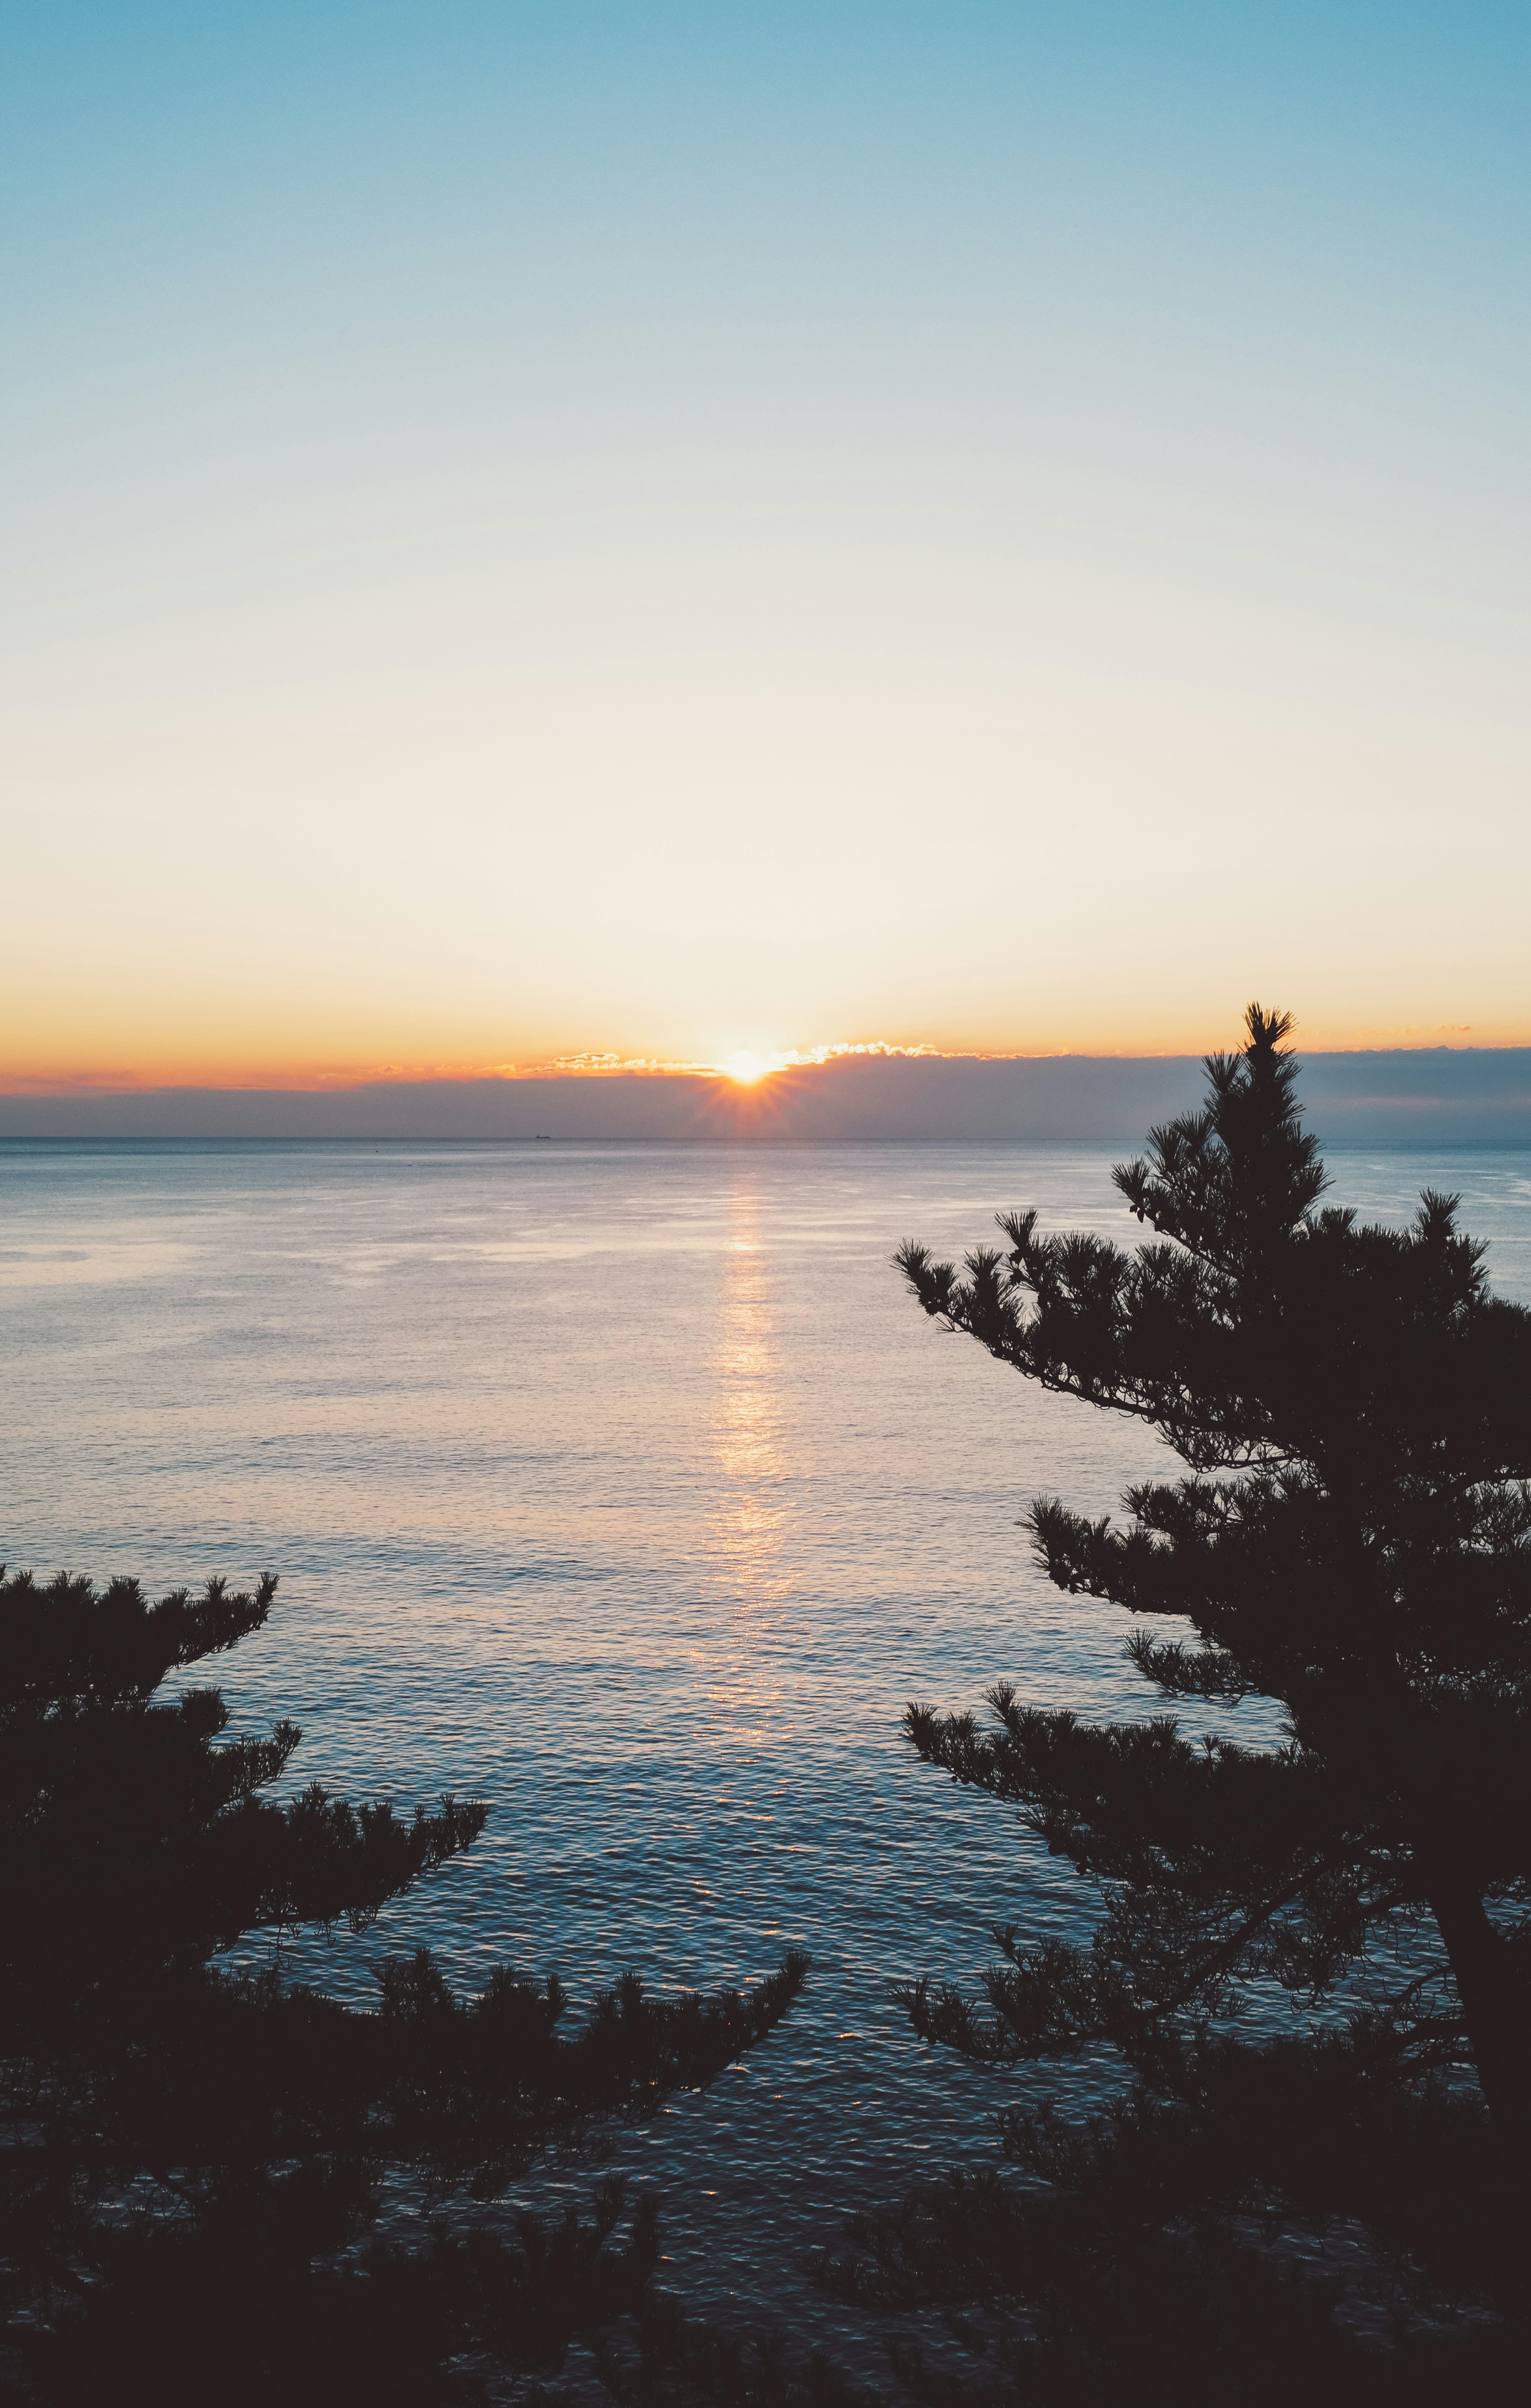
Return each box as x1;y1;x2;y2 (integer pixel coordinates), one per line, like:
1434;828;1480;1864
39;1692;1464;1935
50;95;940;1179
0;1575;807;2408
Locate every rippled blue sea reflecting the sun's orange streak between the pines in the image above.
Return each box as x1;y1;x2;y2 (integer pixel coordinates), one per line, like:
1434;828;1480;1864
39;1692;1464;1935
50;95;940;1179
0;1141;1531;2350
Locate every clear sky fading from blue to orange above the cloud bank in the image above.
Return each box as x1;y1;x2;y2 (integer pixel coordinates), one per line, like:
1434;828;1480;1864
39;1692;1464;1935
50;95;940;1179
0;0;1531;1086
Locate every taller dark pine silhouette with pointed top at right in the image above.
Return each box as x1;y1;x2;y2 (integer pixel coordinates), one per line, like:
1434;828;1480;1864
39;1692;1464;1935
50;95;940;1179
830;1007;1531;2401
